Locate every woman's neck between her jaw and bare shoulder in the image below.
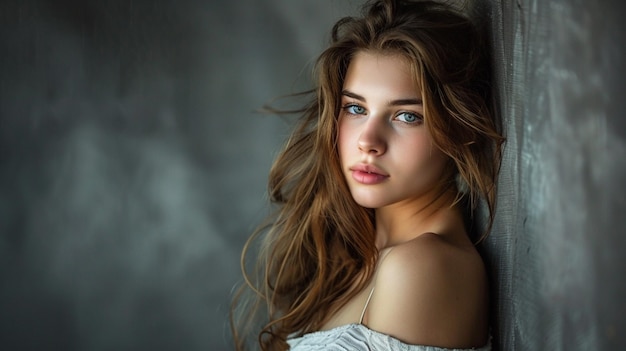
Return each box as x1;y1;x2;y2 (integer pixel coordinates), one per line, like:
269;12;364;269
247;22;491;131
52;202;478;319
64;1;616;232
375;187;463;249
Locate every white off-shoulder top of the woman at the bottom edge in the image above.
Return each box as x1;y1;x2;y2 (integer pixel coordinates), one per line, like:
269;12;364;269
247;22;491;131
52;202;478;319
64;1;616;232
287;323;491;351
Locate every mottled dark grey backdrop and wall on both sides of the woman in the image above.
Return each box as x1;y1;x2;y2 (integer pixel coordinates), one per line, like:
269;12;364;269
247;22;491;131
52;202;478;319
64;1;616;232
0;0;626;351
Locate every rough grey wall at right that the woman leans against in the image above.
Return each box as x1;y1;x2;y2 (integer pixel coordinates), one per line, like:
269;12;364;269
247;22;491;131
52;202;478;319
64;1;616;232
486;0;626;350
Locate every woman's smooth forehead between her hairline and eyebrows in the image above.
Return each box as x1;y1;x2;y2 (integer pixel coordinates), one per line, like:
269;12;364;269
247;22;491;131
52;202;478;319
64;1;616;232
343;51;421;96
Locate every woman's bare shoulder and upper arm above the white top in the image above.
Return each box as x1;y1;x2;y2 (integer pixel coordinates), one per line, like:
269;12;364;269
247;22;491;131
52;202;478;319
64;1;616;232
365;234;488;348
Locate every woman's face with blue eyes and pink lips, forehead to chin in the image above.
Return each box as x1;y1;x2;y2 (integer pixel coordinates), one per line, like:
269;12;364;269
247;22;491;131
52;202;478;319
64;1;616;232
339;52;447;208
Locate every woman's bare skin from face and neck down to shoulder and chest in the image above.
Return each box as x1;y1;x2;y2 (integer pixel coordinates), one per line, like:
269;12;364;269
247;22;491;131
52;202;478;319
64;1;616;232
323;51;488;348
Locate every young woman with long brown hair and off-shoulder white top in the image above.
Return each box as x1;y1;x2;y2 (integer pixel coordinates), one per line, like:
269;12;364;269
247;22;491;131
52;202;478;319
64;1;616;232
233;0;503;350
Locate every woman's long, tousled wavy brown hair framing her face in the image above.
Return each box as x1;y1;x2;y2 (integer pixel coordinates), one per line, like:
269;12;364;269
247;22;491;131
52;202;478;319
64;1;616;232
231;0;504;350
